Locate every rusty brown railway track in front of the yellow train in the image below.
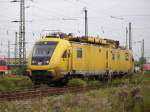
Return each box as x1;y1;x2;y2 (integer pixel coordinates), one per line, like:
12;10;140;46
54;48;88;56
0;87;99;102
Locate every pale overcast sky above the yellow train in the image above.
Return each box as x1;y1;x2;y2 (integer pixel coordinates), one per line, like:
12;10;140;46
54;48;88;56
0;0;150;58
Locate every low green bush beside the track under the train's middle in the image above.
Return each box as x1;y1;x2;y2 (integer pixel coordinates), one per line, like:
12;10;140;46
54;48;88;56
67;78;87;87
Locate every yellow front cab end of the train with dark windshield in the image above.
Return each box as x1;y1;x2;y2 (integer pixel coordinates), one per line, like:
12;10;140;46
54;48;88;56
28;38;70;83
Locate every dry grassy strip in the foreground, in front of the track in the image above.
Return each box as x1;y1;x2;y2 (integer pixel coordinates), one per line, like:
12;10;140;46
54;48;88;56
0;74;150;112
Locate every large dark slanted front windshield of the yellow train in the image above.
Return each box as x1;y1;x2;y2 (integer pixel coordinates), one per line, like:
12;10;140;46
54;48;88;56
32;42;57;65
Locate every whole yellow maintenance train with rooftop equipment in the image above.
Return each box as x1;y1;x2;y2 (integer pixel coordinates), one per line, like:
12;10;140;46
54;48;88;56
28;32;134;83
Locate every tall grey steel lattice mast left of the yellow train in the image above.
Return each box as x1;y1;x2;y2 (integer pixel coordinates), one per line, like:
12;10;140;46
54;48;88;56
19;0;26;65
